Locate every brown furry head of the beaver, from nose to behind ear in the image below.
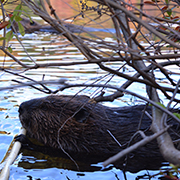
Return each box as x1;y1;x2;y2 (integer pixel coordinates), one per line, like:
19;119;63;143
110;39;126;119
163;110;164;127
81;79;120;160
19;95;117;153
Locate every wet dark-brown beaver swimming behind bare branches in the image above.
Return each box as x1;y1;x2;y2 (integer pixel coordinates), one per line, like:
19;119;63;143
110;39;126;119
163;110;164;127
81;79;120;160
16;95;178;172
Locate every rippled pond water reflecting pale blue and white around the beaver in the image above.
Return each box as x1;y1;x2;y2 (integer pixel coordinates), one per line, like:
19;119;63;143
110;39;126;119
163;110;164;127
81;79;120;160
0;15;179;180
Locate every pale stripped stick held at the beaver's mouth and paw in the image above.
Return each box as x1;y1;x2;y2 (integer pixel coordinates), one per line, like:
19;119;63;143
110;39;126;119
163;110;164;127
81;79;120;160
0;128;26;180
